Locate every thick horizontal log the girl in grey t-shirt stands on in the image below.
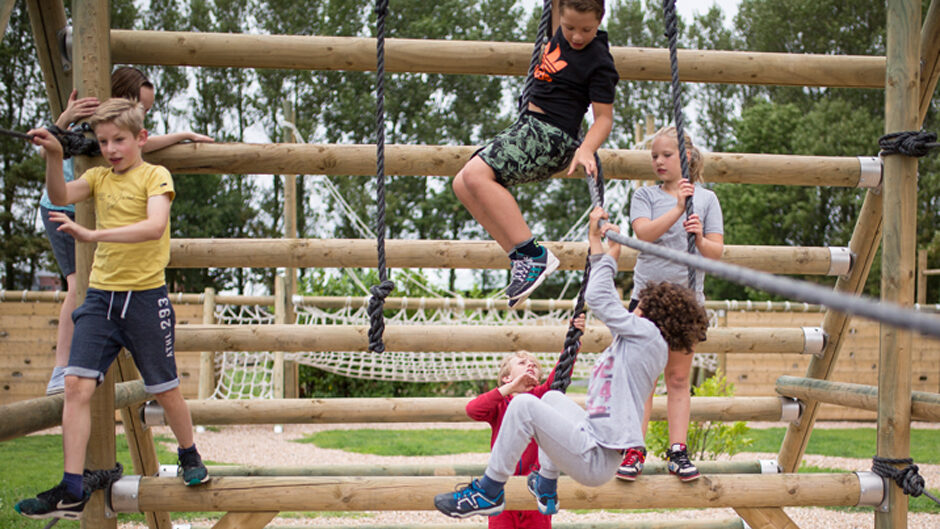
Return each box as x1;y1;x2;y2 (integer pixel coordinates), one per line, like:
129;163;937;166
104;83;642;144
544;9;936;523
125;473;861;512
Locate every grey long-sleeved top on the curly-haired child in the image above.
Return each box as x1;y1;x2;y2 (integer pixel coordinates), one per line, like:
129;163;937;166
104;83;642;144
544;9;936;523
584;254;669;449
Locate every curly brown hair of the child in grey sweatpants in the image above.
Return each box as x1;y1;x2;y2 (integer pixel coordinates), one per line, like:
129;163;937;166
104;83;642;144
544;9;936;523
637;282;708;353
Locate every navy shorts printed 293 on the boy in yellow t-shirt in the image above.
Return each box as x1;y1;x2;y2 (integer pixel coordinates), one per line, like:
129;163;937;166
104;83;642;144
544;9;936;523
65;286;180;394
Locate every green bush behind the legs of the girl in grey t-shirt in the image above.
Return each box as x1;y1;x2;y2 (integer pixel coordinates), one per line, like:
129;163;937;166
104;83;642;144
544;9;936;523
646;371;753;460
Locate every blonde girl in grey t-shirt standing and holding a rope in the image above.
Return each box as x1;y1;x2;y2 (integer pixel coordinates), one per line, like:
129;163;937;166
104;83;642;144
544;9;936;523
617;127;724;481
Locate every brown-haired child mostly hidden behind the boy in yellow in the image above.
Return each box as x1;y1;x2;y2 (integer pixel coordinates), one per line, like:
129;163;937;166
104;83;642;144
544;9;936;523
39;66;214;395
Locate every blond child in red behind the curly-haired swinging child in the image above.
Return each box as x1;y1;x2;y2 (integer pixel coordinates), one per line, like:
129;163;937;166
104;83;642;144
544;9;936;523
467;314;584;529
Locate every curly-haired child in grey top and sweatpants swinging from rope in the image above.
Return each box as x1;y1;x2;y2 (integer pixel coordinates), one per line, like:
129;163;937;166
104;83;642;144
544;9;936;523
434;207;708;518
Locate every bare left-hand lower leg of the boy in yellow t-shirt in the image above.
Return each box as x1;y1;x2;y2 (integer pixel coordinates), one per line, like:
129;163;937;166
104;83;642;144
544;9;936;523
62;375;97;475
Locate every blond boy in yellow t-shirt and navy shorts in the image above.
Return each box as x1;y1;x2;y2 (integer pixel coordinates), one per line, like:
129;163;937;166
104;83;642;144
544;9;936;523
14;98;209;519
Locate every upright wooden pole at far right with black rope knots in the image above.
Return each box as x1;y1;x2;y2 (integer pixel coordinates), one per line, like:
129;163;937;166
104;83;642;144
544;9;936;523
875;0;921;529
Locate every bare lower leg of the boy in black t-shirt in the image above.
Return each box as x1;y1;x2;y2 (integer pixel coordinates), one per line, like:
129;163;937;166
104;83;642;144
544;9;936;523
453;156;532;253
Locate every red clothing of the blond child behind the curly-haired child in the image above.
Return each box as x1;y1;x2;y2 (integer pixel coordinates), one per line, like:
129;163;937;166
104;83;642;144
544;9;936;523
467;346;580;529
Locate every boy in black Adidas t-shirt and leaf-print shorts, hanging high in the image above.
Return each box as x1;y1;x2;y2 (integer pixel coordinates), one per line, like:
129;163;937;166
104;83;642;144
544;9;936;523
453;0;619;307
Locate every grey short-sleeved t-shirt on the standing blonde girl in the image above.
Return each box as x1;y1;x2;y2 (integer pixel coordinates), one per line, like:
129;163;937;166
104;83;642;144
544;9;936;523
630;184;724;303
